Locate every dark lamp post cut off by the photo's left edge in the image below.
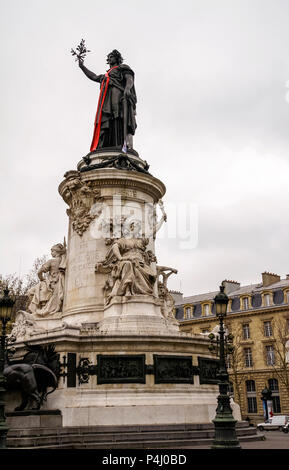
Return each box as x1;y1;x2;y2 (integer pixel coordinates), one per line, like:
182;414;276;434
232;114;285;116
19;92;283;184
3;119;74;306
0;289;15;449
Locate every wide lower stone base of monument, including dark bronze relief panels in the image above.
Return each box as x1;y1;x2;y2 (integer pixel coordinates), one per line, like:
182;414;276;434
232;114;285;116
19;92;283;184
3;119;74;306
7;326;241;427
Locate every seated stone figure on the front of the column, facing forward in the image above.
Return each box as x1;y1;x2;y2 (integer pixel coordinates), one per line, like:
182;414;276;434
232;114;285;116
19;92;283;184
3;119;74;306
95;231;157;304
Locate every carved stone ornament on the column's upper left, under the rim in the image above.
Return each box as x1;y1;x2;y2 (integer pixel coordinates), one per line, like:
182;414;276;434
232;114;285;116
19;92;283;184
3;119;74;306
63;172;102;236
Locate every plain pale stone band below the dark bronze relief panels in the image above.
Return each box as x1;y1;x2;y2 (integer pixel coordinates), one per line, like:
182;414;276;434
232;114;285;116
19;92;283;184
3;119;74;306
46;385;241;426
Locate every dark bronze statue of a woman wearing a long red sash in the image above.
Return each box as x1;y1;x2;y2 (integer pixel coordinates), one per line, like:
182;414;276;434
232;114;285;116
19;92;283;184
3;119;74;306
76;44;137;152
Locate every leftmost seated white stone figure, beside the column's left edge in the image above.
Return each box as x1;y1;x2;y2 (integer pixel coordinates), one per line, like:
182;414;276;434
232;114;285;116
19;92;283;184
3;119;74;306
28;242;66;316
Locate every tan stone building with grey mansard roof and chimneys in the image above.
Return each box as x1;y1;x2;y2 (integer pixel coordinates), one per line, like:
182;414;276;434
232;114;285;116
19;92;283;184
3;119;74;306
172;272;289;424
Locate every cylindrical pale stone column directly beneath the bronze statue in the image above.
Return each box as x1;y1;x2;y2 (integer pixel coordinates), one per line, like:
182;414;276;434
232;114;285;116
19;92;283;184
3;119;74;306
59;152;165;324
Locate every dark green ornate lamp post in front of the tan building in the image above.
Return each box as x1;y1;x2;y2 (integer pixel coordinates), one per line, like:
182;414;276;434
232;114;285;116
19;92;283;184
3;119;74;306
212;285;241;449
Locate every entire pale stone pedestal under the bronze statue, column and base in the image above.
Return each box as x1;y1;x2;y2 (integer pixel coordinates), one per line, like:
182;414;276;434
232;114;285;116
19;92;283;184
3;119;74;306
8;151;240;426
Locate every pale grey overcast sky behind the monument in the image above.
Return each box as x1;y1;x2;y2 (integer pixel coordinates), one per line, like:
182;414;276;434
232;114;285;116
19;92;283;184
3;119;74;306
0;0;289;295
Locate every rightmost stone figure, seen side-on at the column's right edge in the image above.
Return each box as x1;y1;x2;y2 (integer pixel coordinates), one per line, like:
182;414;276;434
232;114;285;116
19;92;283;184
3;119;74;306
157;266;179;325
